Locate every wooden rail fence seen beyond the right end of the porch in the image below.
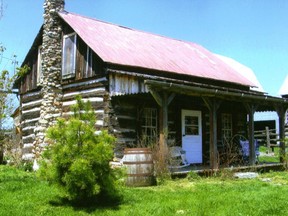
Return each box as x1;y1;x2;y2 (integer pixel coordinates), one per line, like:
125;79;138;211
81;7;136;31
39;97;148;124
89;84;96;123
254;127;288;151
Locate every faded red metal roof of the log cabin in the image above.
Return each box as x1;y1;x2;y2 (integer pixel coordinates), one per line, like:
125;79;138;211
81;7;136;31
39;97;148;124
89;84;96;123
59;11;253;86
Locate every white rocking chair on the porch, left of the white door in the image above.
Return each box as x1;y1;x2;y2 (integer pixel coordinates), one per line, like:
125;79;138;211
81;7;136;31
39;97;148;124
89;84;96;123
169;146;190;168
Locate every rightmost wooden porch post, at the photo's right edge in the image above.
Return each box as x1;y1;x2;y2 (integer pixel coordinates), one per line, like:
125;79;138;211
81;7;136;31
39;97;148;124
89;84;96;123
276;106;286;163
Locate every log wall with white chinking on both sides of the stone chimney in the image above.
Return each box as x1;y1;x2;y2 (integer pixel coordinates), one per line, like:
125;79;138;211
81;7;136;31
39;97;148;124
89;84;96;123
21;77;109;159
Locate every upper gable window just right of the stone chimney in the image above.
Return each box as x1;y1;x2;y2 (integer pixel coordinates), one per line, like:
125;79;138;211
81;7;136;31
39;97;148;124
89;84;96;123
62;33;77;79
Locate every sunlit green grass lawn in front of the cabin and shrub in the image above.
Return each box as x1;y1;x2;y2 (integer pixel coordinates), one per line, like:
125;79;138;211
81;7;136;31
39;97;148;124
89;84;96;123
0;166;288;216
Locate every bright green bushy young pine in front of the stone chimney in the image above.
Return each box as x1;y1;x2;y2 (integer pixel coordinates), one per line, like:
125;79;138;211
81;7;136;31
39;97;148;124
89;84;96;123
40;97;121;200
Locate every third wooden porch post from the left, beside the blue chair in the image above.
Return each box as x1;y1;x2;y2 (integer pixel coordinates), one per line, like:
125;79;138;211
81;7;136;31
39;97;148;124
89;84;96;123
244;103;256;166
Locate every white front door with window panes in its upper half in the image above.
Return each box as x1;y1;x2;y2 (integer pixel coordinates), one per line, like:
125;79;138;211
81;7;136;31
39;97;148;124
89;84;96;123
181;110;202;163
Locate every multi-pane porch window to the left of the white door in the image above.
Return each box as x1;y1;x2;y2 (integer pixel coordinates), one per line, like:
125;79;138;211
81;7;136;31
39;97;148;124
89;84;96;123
141;108;158;146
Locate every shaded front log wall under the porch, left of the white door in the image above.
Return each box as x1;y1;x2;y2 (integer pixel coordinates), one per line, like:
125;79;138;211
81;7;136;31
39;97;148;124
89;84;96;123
109;93;181;157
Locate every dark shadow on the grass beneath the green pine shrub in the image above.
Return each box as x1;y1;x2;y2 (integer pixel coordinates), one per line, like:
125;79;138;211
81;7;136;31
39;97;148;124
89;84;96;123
49;192;123;213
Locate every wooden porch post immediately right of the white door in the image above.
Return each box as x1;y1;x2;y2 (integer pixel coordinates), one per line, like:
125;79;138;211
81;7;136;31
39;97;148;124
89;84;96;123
202;98;221;169
